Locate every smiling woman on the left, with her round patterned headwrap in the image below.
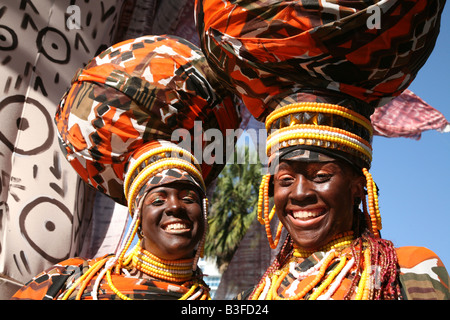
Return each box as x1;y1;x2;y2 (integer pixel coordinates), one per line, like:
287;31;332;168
13;36;240;300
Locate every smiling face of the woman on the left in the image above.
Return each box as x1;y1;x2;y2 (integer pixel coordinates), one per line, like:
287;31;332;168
141;182;205;260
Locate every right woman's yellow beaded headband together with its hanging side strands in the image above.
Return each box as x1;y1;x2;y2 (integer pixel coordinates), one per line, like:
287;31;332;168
258;102;381;249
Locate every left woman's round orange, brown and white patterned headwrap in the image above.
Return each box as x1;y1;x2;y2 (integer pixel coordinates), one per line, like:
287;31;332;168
55;36;240;211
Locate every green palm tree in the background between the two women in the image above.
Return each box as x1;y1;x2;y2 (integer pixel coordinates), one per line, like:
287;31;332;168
205;147;261;272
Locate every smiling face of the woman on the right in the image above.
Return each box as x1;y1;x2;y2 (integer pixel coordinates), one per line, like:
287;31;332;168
274;161;364;250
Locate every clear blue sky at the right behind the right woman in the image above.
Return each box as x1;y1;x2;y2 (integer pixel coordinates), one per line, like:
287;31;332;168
371;5;450;271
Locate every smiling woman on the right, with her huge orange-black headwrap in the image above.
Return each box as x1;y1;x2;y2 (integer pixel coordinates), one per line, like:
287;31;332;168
196;0;450;300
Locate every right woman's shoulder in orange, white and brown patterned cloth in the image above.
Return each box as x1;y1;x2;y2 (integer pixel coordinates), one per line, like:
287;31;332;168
396;246;450;300
